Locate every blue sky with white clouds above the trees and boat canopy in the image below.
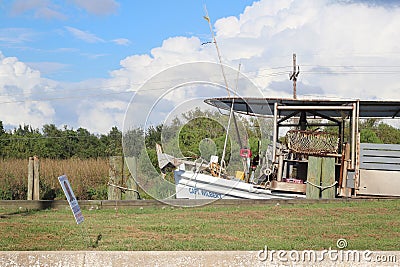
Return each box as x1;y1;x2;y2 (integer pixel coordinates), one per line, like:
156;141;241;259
0;0;400;133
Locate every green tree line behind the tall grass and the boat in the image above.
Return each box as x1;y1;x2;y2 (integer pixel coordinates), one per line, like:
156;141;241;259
0;116;400;160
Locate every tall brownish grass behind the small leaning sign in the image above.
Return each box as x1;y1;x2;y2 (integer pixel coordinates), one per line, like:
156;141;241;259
0;158;109;199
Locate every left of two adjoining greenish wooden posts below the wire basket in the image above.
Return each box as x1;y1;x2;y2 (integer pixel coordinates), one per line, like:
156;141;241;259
306;156;322;199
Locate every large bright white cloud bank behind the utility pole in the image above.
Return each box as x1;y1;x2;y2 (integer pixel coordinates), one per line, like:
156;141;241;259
106;0;400;102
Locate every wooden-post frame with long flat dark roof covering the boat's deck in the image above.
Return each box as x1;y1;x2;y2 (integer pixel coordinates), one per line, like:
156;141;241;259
205;97;400;196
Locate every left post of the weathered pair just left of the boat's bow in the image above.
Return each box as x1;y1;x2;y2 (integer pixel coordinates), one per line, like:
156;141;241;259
108;156;123;200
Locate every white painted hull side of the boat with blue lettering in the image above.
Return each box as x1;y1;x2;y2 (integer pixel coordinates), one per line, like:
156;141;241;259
174;170;305;199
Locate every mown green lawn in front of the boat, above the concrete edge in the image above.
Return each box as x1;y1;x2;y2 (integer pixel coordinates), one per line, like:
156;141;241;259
0;200;400;250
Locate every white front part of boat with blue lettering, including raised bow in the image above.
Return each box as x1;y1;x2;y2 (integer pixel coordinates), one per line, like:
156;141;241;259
157;143;305;199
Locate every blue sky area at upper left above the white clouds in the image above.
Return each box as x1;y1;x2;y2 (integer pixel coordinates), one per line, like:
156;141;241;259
0;0;253;82
